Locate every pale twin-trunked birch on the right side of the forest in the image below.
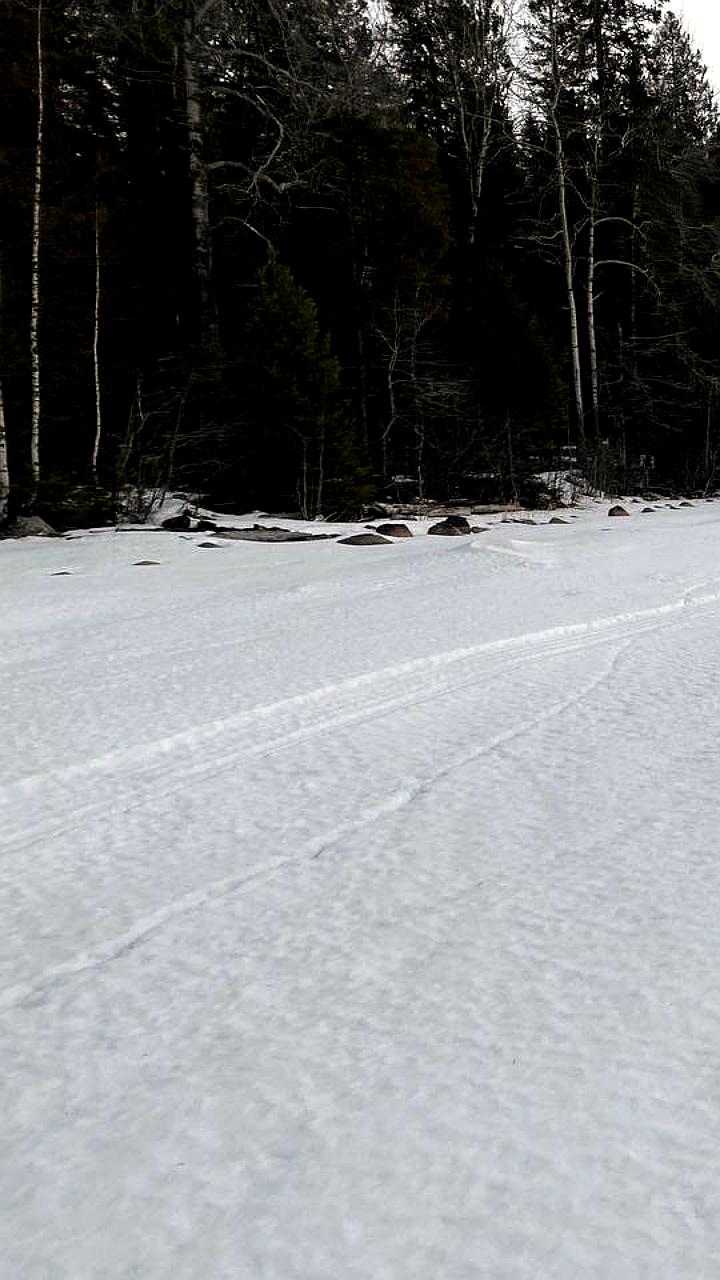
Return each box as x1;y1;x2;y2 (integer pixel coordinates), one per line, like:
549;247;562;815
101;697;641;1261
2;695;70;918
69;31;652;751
520;0;657;451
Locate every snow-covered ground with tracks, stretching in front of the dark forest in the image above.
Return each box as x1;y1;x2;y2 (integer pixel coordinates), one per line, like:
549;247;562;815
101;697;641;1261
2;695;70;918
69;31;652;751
0;503;720;1280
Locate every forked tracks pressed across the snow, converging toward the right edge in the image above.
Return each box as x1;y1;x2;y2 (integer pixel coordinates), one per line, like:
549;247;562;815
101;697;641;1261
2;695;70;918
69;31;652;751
0;584;720;1010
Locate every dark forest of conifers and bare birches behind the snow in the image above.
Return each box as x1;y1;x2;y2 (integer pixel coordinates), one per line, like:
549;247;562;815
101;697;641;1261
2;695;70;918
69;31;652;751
0;0;720;527
